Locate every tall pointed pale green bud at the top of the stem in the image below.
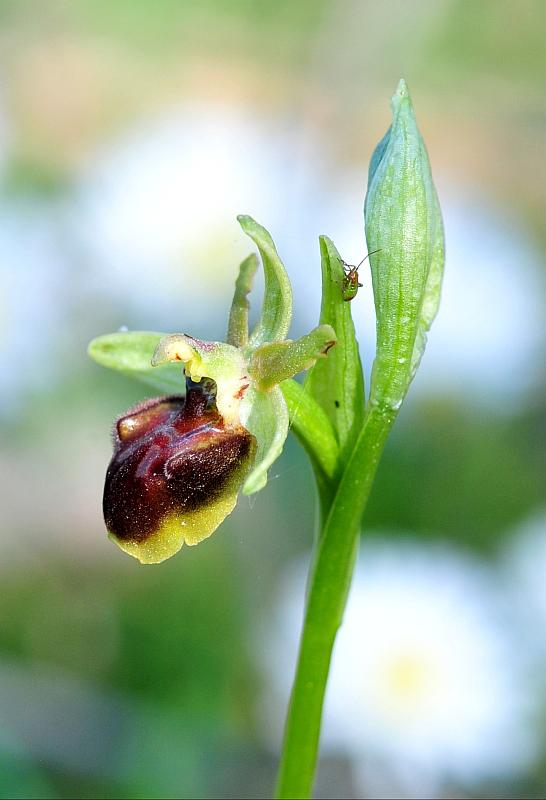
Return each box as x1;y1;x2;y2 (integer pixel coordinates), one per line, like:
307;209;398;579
365;80;444;410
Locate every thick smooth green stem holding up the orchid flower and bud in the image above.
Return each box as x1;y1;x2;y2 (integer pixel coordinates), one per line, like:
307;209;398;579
277;406;396;798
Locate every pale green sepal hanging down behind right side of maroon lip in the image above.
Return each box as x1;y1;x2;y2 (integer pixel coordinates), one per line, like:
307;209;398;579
241;386;289;494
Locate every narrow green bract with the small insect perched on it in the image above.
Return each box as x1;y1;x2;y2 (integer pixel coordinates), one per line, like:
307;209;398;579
305;236;365;460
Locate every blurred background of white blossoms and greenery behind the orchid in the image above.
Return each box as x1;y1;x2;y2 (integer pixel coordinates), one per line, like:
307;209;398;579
0;0;546;798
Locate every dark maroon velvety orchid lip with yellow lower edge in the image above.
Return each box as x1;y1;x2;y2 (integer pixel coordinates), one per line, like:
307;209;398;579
103;379;256;564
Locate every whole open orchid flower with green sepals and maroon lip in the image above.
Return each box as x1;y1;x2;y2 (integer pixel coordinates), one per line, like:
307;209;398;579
89;216;336;563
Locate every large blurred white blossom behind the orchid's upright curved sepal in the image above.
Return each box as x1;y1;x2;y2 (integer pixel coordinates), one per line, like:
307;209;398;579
72;103;320;335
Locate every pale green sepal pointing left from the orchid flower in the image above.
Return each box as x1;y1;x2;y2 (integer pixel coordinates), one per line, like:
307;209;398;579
87;331;186;394
